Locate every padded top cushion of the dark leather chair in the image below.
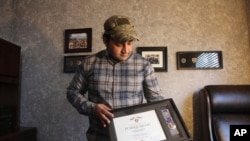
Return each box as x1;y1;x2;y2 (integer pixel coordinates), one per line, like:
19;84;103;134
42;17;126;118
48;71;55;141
205;85;250;113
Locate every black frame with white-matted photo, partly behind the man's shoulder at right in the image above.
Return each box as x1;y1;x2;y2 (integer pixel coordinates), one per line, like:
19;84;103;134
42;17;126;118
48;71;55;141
137;47;168;72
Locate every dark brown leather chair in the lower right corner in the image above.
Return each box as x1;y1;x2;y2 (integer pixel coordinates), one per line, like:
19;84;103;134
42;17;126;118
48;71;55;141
193;85;250;141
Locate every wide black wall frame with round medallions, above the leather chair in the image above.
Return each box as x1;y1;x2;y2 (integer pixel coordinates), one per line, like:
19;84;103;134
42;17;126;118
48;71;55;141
176;51;223;70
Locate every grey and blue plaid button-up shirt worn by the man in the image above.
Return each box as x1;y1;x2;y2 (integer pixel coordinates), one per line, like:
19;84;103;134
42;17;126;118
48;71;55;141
67;50;163;141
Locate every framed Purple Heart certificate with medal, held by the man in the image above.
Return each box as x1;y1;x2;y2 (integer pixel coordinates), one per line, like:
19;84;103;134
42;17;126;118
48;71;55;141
108;99;192;141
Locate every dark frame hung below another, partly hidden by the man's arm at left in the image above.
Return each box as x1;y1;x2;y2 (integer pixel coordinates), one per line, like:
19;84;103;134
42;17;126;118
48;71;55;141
63;55;88;73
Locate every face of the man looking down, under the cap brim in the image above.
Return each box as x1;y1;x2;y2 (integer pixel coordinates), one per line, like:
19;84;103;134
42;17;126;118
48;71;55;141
106;40;133;61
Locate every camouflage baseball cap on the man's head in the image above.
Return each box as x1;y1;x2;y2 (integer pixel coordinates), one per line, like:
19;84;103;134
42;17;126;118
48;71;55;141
104;15;139;43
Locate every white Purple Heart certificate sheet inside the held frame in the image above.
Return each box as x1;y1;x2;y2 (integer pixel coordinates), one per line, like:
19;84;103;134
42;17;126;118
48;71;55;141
113;110;167;141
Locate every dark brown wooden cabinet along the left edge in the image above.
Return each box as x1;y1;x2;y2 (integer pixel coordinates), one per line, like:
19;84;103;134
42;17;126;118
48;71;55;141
0;39;36;141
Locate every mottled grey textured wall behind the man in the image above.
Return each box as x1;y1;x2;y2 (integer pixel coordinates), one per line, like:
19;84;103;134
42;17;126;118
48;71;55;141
0;0;250;141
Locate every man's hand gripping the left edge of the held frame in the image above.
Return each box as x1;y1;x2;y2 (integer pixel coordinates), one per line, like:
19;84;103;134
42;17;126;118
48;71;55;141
95;104;114;127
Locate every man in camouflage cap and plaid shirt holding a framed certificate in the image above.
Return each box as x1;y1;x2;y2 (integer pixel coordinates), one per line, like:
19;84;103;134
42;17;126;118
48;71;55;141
67;15;163;141
